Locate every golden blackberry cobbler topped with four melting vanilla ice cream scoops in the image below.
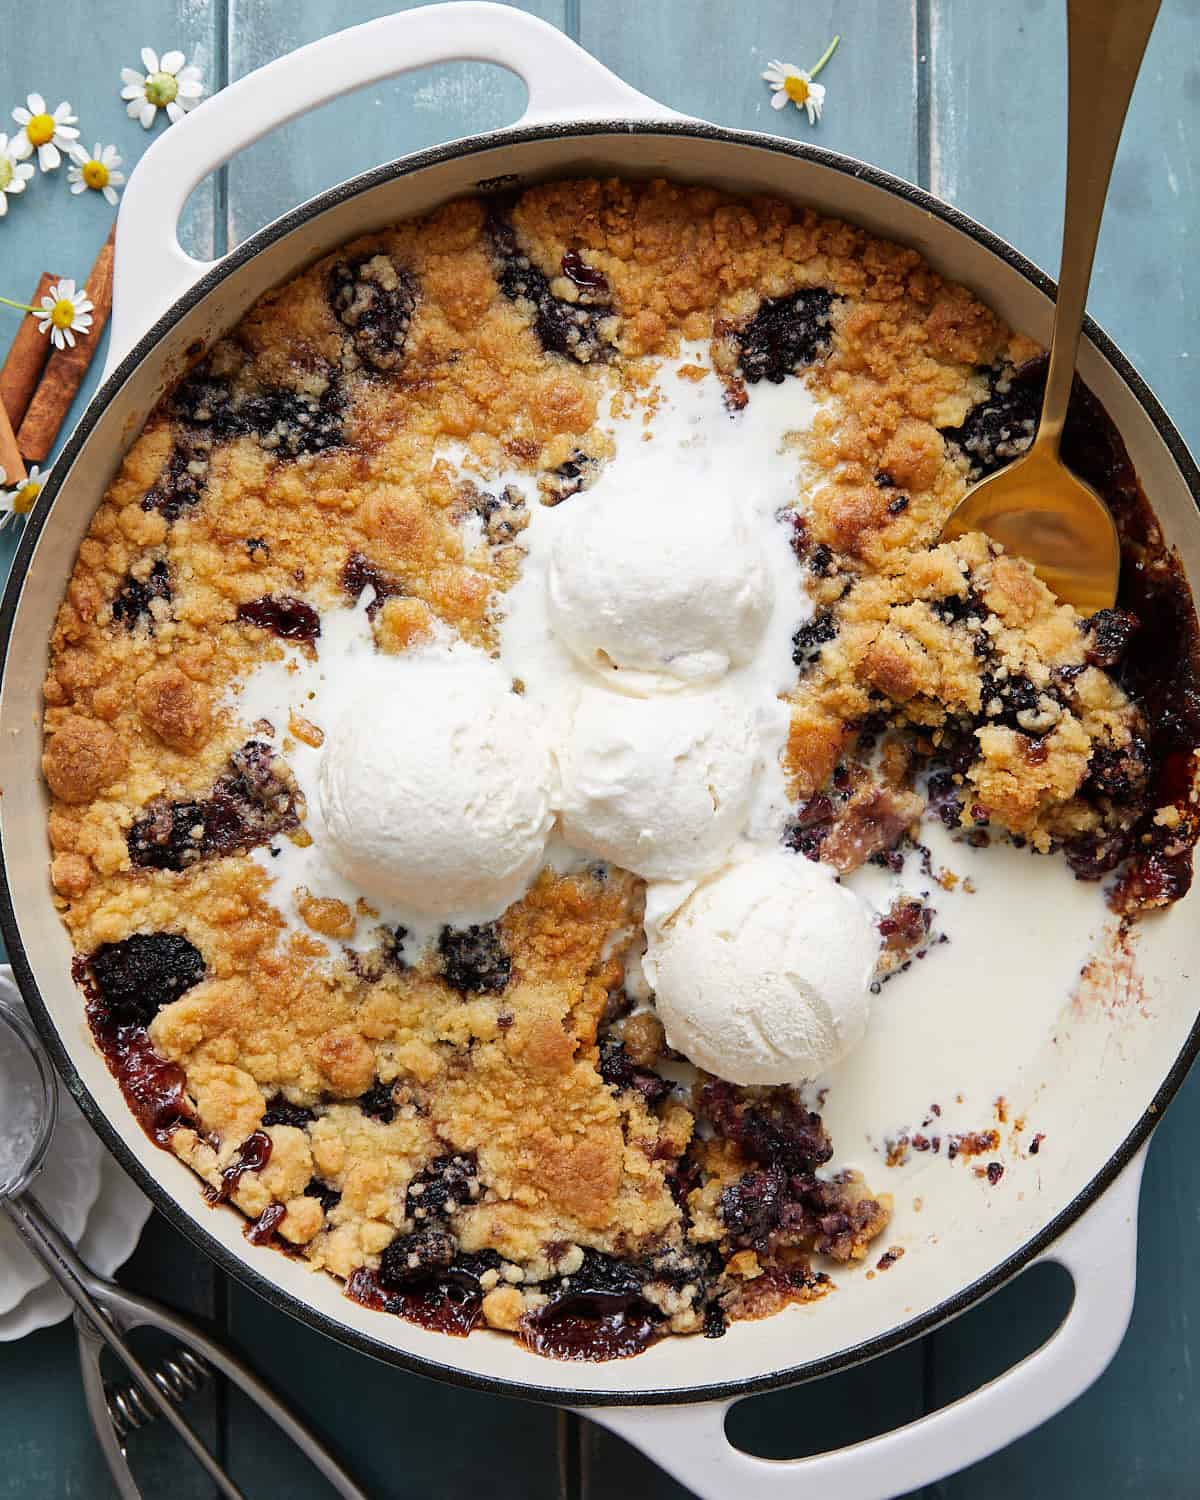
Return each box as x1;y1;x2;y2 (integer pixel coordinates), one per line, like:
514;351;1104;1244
44;180;1200;1358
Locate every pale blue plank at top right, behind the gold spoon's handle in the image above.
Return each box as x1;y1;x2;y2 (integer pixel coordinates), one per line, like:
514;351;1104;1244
929;0;1200;447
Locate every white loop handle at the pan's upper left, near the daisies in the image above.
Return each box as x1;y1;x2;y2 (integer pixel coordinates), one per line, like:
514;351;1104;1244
105;0;681;375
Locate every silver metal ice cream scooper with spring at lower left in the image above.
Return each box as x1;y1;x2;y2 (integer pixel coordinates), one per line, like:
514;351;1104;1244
0;1001;368;1500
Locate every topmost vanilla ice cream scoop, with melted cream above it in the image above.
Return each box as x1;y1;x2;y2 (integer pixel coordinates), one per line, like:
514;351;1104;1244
546;483;771;695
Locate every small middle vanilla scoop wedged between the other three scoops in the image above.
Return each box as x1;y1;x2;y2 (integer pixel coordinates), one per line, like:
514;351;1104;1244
560;689;758;881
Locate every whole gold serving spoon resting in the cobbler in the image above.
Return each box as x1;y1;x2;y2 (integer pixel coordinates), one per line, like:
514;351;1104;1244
942;0;1161;615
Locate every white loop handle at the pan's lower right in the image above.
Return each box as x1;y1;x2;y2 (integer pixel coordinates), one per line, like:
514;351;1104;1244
579;1146;1146;1500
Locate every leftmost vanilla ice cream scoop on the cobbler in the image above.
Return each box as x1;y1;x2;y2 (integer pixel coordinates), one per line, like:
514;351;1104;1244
318;651;555;924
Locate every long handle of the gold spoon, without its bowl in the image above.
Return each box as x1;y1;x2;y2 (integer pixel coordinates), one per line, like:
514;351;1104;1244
1037;0;1161;458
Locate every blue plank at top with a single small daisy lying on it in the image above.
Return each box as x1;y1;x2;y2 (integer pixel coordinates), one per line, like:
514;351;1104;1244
579;0;920;180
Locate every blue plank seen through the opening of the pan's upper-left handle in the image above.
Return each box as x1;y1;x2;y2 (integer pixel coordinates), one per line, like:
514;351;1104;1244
228;0;566;245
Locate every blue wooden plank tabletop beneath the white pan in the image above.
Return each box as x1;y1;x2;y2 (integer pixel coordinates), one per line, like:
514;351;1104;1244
0;0;1200;1500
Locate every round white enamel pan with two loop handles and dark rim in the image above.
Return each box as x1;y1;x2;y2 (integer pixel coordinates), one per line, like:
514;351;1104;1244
0;3;1200;1500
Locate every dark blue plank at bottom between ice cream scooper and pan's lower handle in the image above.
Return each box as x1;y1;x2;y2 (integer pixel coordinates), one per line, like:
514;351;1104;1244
227;1284;558;1500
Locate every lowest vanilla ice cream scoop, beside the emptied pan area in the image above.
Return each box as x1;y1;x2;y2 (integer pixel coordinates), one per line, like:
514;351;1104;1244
642;849;879;1083
